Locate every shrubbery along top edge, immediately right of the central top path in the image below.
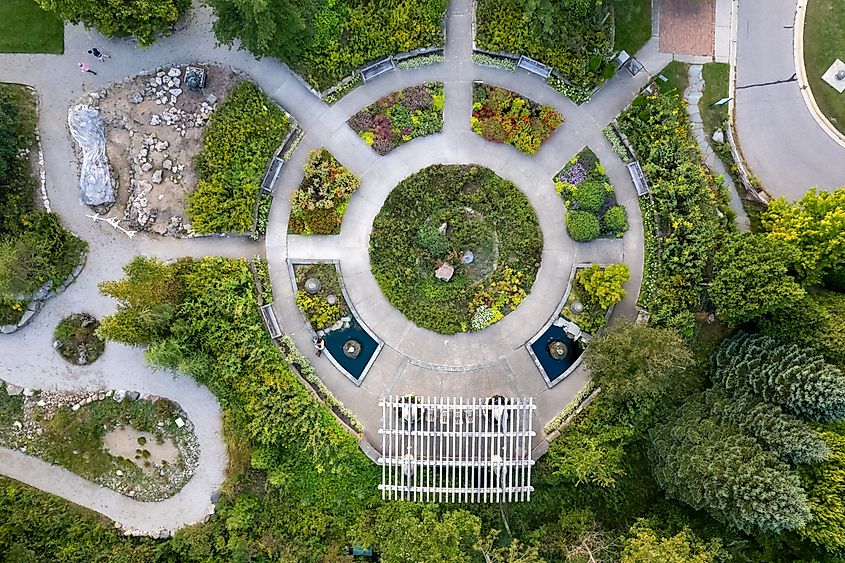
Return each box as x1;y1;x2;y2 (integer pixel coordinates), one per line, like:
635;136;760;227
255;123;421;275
476;0;616;89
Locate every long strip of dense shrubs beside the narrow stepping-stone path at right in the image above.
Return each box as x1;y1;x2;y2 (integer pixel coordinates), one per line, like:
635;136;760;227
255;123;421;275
619;80;728;336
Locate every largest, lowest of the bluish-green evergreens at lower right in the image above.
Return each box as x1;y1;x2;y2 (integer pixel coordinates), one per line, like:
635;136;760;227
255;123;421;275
649;396;810;533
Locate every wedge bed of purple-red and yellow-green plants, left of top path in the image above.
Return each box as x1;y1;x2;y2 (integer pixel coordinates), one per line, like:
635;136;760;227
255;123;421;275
348;82;445;154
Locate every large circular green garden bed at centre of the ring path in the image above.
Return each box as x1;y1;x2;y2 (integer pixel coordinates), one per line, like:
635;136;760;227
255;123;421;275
370;165;543;334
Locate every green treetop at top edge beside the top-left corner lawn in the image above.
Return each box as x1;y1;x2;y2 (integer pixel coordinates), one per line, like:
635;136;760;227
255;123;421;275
35;0;191;46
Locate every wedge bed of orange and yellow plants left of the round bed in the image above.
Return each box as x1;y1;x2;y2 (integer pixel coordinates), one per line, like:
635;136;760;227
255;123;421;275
288;148;361;235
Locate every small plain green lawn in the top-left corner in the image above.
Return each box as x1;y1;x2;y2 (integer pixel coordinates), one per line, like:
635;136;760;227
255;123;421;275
0;0;65;53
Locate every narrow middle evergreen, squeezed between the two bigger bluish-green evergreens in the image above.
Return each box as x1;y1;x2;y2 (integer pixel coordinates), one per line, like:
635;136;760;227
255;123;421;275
704;387;830;465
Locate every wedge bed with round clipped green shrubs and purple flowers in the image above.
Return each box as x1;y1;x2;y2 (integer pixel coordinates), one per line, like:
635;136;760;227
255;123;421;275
555;147;628;242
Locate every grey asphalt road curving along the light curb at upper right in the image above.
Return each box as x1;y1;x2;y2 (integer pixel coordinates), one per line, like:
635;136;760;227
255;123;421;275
736;0;845;200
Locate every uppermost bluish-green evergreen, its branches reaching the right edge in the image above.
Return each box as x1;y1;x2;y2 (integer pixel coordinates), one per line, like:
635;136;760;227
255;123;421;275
712;332;845;422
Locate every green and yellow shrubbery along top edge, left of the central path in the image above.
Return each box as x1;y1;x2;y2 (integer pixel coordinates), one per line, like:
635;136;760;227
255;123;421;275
209;0;446;90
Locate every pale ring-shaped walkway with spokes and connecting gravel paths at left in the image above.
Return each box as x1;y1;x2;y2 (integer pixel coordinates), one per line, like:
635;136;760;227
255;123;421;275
0;0;668;530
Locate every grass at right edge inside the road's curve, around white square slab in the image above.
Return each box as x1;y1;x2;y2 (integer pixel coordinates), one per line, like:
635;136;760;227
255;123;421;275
804;0;845;133
